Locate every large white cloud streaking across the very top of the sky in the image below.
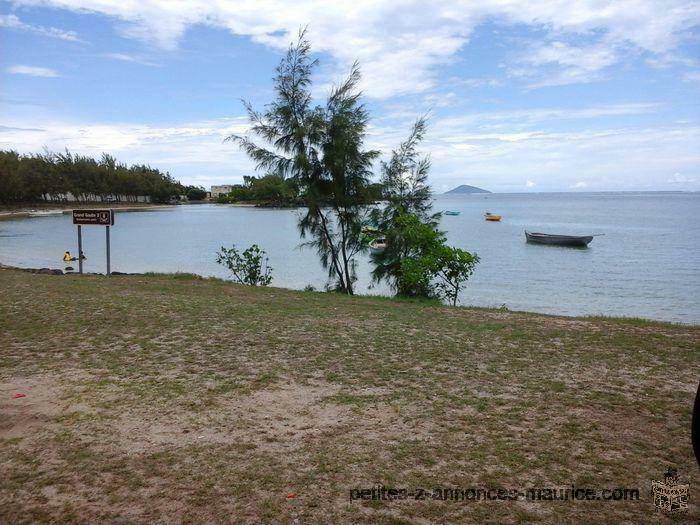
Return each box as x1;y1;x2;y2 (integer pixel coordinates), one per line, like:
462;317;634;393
6;0;700;98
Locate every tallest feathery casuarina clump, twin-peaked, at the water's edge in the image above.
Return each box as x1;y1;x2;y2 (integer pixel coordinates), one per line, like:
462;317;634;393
228;31;378;294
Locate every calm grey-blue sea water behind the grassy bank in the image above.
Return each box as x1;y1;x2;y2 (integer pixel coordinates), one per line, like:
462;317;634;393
0;193;700;323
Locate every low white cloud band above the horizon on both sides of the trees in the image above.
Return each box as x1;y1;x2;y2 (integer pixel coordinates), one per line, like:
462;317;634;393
0;108;700;191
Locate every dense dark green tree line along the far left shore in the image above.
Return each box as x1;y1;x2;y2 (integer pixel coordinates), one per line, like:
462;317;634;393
0;151;189;203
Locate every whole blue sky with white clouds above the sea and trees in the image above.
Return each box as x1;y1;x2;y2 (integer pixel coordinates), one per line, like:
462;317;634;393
0;0;700;192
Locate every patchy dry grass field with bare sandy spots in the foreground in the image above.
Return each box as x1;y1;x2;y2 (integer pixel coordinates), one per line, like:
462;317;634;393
0;270;700;525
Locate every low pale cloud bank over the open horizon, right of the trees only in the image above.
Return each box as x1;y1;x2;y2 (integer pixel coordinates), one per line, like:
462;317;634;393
400;116;700;192
